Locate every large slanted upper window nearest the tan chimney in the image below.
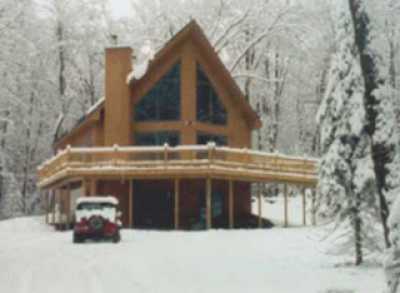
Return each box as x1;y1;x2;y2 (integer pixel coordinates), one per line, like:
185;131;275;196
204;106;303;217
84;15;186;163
135;63;181;121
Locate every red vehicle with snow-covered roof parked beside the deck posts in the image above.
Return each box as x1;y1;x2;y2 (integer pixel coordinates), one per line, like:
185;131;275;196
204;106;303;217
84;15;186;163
73;196;122;243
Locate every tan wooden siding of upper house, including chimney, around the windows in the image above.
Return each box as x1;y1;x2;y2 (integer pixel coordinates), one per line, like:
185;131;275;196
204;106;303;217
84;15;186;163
58;33;251;149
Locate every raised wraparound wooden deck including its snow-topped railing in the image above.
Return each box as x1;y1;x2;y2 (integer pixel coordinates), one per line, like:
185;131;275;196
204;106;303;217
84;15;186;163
38;144;317;188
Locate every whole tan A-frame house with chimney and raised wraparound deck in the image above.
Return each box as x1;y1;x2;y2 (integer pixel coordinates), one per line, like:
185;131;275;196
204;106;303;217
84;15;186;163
38;21;316;229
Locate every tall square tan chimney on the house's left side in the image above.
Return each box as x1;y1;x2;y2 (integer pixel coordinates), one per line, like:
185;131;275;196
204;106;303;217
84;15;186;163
104;47;132;146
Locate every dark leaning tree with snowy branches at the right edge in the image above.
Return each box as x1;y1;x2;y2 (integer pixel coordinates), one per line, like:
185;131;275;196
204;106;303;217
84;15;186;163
349;0;400;247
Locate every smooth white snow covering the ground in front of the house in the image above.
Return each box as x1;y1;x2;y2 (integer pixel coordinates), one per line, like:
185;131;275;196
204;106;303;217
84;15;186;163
0;196;384;293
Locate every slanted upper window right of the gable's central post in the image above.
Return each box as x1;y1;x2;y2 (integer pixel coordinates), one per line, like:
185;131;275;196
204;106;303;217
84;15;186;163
197;64;227;125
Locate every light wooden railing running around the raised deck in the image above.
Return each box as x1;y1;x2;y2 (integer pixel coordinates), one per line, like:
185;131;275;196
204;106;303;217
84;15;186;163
38;143;317;184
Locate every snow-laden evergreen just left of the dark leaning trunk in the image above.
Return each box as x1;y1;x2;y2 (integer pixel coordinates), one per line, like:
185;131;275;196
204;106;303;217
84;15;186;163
318;0;374;265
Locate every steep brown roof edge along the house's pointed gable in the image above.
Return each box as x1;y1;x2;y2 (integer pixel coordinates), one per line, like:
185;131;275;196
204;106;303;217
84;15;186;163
56;20;261;144
